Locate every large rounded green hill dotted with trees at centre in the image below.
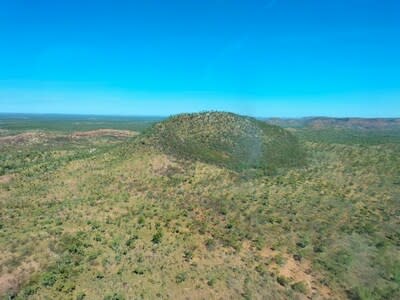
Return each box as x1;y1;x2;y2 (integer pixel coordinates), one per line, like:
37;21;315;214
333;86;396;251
147;112;305;172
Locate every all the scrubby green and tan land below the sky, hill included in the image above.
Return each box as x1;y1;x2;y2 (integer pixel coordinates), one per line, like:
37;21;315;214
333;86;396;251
0;112;400;299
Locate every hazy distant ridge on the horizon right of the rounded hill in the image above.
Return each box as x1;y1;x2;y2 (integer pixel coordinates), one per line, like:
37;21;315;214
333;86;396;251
265;117;400;130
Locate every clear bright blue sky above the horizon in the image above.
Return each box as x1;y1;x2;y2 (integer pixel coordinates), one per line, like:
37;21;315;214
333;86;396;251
0;0;400;117
